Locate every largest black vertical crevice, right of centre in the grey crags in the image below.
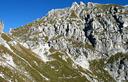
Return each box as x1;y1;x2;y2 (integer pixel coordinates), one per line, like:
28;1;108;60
83;15;96;47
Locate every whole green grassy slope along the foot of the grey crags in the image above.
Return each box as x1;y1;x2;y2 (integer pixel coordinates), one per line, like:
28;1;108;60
0;34;127;82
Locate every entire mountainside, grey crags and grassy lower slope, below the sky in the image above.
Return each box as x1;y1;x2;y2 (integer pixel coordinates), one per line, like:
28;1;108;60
0;2;128;82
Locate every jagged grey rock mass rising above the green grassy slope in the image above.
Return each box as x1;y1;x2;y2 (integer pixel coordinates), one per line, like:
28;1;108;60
12;2;128;82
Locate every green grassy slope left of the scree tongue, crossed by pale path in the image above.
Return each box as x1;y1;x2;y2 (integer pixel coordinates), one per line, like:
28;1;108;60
0;44;89;82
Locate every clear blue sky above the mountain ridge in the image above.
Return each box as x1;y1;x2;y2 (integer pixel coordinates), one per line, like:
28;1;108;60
0;0;128;32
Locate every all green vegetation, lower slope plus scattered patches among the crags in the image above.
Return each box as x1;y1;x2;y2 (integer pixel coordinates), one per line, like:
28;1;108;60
0;4;128;82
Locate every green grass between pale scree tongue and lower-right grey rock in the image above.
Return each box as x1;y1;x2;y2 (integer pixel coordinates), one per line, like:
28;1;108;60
90;59;116;82
